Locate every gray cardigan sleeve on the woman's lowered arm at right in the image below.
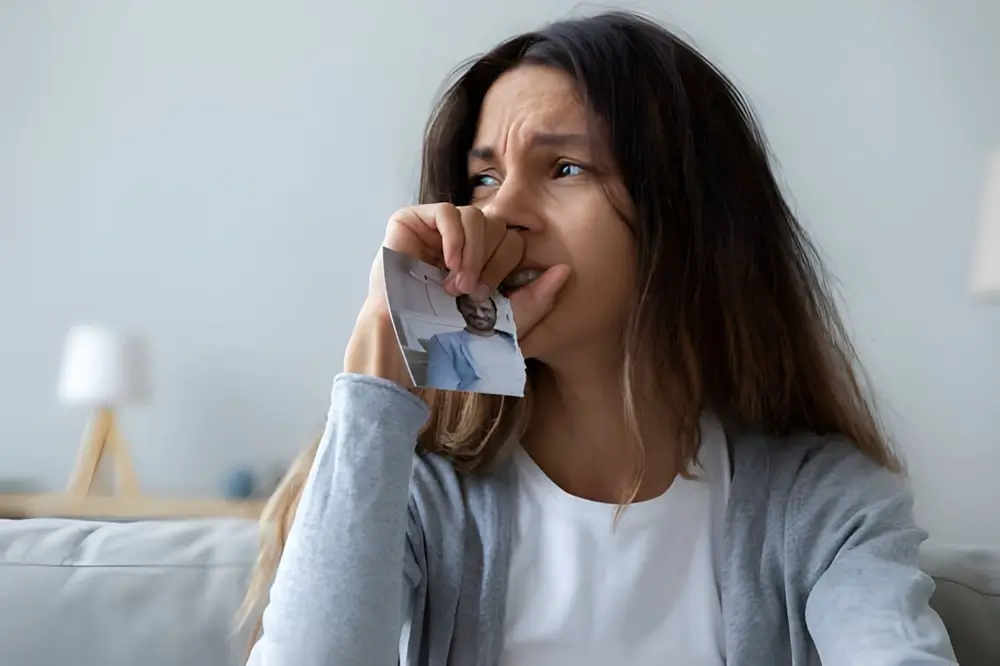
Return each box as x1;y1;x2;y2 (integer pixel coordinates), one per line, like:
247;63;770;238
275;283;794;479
785;443;957;666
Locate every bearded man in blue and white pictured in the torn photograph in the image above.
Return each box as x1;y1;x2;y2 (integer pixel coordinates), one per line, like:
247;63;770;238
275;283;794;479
427;294;525;396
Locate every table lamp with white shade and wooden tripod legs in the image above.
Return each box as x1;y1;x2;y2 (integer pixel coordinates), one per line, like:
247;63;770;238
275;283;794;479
58;326;148;497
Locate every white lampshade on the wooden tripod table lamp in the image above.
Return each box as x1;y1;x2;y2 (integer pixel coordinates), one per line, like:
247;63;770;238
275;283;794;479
59;326;149;407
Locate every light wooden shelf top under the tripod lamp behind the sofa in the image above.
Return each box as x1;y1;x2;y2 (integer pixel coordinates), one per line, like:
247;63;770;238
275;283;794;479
0;493;264;520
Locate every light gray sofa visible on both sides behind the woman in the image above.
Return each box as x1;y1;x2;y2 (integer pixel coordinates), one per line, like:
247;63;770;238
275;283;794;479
0;519;1000;666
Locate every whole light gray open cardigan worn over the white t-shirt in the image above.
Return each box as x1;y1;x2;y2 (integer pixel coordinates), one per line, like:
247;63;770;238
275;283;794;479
248;374;957;666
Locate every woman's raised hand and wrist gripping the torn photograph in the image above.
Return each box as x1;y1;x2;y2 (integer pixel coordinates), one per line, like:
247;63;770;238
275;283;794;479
344;203;569;386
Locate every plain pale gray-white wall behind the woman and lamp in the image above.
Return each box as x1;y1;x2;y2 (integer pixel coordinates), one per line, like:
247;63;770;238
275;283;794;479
0;0;1000;545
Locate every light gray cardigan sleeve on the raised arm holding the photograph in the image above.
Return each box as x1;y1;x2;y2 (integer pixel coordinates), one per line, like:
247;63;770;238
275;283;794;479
248;374;428;666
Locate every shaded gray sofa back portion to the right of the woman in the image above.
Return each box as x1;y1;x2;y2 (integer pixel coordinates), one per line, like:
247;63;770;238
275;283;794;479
921;543;1000;666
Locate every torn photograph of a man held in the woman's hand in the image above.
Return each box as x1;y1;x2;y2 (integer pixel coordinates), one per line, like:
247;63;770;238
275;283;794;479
382;248;525;397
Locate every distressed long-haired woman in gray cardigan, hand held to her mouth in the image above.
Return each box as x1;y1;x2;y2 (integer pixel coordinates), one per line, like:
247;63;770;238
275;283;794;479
240;13;953;666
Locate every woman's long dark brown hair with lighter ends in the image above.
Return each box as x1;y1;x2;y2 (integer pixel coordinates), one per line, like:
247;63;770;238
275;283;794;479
244;12;900;637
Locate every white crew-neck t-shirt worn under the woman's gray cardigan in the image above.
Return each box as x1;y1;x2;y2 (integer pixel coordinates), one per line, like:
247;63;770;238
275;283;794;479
500;416;730;666
